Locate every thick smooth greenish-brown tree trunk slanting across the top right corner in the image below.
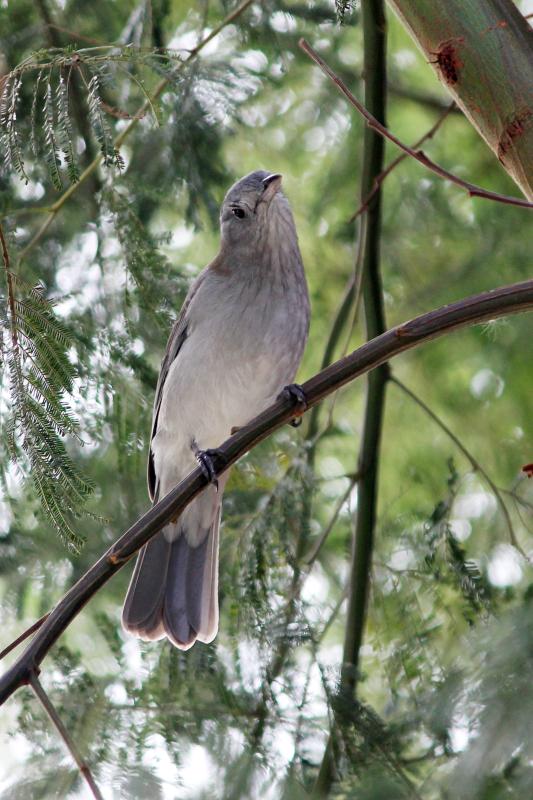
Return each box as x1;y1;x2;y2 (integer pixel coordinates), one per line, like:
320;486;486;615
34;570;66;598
389;0;533;200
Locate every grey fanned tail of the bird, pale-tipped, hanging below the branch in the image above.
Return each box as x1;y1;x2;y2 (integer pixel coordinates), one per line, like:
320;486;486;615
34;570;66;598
122;490;220;650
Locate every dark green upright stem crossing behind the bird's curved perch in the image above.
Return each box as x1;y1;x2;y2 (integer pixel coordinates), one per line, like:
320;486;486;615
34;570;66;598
315;0;388;796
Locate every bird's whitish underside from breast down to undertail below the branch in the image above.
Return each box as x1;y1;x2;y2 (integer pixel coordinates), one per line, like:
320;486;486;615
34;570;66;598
152;260;305;545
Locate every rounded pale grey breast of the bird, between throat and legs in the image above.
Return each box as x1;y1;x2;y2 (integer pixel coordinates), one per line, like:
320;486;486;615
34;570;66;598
158;274;307;449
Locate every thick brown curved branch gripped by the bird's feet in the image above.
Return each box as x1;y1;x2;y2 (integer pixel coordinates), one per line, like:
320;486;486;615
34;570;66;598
0;280;533;704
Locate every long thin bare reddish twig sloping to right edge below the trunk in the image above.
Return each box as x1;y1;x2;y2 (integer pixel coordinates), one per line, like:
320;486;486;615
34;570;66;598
299;39;533;208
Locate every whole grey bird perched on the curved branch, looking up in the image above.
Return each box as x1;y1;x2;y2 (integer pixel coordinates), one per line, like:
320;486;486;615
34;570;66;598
122;170;309;650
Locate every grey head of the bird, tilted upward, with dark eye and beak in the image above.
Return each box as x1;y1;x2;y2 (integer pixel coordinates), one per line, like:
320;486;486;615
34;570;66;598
220;170;292;249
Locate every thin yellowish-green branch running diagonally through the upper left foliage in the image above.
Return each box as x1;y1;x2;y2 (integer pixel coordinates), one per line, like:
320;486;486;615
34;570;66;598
12;0;253;264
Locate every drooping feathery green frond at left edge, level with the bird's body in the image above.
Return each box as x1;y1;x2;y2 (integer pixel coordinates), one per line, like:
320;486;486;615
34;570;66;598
2;275;92;550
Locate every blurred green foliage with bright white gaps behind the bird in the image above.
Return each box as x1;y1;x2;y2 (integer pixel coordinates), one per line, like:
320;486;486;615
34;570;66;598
0;0;533;800
